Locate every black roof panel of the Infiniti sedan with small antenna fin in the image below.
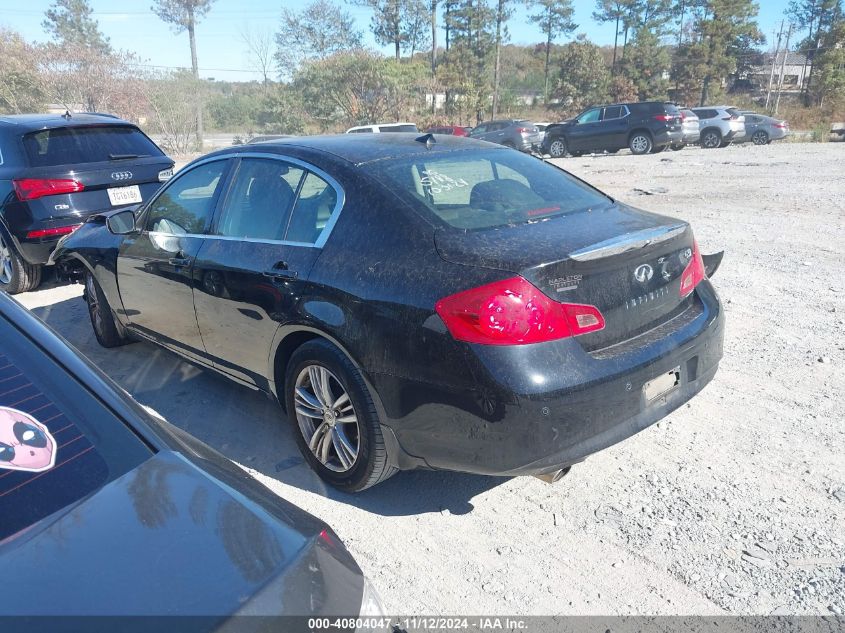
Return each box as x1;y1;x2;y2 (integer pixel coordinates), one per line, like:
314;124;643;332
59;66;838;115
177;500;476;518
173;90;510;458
214;132;504;165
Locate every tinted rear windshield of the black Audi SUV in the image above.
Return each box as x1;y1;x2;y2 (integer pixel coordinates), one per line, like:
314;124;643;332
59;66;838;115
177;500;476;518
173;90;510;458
23;125;164;167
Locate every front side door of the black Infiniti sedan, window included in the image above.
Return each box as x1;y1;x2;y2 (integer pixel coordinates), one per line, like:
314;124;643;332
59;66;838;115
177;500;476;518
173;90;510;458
117;158;231;360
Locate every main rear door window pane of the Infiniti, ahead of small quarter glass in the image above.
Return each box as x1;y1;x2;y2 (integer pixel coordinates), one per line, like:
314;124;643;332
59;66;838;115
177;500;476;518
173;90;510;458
217;158;305;240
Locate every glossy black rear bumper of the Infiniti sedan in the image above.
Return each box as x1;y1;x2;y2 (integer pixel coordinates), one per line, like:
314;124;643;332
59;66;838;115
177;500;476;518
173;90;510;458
374;281;724;476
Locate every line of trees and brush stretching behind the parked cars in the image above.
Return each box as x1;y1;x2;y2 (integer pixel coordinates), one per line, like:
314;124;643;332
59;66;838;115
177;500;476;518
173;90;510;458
0;0;845;150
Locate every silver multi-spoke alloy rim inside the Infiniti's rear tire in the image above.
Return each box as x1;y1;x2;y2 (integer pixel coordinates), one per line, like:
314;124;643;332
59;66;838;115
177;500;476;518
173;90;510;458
294;365;361;473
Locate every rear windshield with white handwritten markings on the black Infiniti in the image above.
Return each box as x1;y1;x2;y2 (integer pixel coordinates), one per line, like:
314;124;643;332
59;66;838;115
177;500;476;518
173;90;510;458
364;149;610;229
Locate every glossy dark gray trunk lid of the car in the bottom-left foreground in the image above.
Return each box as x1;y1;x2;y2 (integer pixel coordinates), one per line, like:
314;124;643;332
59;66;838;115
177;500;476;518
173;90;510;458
0;451;363;616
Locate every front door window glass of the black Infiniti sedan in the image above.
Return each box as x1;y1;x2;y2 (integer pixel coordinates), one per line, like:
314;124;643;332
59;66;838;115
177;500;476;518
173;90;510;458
146;160;229;235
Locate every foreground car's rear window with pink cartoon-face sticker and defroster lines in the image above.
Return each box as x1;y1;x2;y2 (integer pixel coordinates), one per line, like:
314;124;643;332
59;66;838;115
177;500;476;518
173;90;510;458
0;320;152;542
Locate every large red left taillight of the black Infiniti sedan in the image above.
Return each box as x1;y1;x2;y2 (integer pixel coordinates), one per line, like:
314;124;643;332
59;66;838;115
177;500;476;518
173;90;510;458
434;277;604;345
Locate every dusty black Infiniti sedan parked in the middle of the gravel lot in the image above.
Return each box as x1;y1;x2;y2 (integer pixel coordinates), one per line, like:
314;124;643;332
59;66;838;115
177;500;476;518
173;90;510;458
57;134;724;490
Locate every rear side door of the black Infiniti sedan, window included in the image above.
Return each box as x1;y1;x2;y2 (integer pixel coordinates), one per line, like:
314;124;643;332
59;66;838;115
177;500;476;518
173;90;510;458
194;154;343;388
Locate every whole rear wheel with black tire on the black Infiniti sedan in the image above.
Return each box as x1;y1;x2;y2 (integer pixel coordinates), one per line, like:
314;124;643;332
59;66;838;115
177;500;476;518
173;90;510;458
285;339;397;492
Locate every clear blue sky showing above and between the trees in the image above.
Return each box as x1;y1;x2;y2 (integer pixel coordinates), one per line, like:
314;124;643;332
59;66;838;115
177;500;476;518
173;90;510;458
0;0;788;81
